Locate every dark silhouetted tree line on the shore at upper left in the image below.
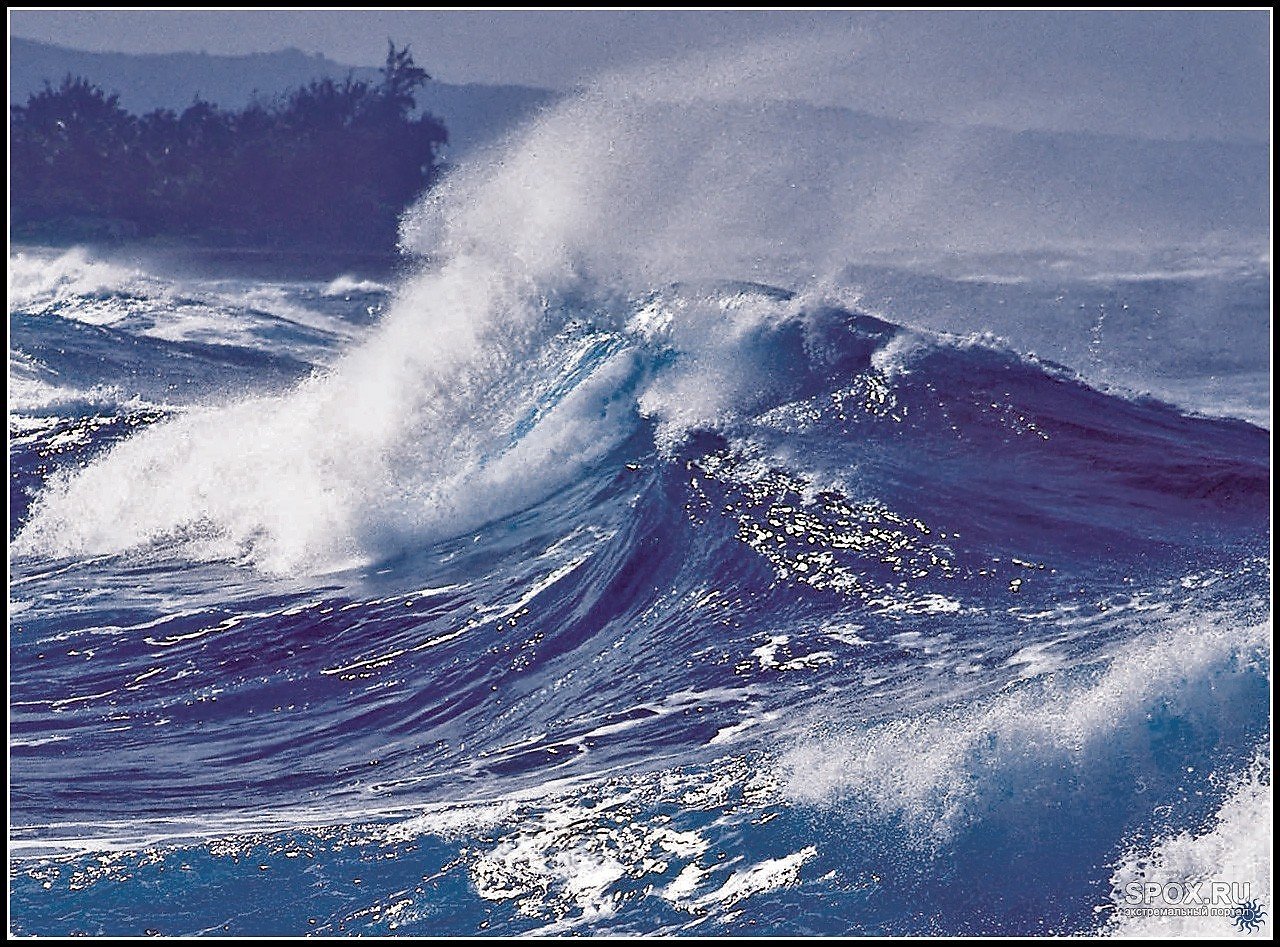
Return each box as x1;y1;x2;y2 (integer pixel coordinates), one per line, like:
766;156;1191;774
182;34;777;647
9;44;447;250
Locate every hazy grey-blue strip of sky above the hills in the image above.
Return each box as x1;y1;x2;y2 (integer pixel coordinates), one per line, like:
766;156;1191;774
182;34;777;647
10;9;1271;139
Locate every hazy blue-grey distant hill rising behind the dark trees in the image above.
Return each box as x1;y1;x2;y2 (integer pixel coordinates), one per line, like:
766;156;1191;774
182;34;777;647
9;37;557;159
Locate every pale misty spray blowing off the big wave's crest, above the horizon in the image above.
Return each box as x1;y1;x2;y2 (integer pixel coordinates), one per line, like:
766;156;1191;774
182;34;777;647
404;43;1267;281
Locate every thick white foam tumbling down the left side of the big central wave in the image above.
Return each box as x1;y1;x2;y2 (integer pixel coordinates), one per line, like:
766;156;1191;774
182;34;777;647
8;252;645;571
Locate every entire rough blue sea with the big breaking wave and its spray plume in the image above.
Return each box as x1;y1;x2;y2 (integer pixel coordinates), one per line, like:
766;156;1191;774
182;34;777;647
10;70;1271;935
